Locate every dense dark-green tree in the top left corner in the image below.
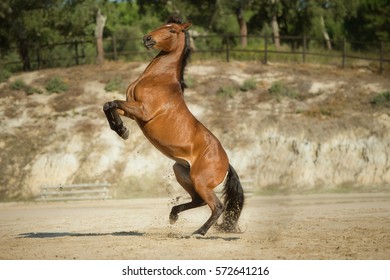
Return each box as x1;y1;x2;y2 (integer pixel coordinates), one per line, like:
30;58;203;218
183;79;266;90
0;0;100;71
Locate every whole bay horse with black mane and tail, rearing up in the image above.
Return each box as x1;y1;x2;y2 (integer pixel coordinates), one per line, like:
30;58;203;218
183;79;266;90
103;18;244;236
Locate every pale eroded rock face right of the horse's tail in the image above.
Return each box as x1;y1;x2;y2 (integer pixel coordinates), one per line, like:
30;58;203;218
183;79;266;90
232;115;390;190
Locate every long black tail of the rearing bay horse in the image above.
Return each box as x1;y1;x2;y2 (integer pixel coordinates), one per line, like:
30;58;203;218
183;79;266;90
218;165;244;232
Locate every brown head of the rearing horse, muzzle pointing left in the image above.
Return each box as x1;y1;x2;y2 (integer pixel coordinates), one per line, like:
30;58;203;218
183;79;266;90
144;23;191;52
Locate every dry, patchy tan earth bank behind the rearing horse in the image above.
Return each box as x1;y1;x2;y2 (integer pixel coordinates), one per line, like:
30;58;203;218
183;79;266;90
0;60;390;199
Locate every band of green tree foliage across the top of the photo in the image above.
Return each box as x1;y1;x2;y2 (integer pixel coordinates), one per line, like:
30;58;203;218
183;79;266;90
0;0;390;71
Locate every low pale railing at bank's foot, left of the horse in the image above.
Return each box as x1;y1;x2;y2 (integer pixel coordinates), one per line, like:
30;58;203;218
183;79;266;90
35;183;111;201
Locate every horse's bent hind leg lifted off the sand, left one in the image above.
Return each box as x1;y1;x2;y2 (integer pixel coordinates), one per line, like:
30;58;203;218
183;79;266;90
169;163;205;224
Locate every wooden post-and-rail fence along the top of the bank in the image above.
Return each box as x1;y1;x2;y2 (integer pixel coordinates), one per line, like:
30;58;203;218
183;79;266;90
0;34;390;73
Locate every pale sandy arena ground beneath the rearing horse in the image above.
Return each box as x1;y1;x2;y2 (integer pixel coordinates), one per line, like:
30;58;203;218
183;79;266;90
0;193;390;260
